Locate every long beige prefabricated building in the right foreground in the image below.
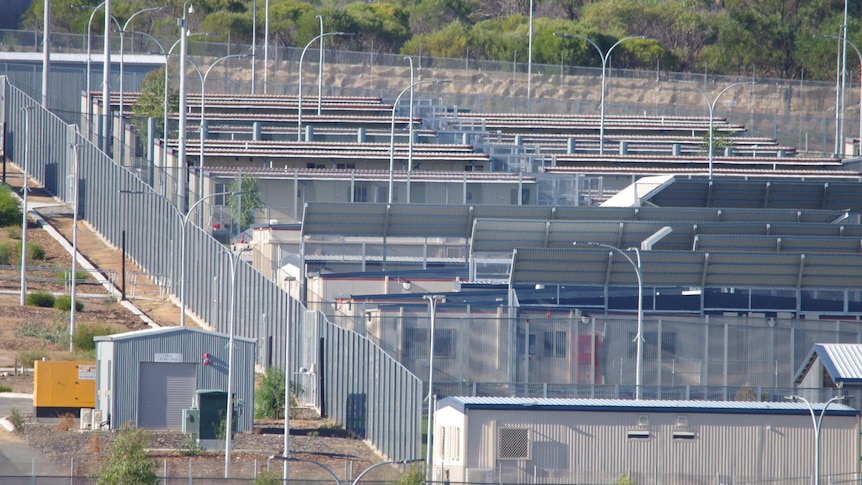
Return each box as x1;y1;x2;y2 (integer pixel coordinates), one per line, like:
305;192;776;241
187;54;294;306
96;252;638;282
432;397;860;485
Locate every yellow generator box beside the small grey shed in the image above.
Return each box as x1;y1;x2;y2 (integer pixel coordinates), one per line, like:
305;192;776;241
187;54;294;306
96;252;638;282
33;361;96;418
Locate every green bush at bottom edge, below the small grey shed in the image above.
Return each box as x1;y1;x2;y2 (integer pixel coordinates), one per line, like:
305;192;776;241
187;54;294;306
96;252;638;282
97;424;159;485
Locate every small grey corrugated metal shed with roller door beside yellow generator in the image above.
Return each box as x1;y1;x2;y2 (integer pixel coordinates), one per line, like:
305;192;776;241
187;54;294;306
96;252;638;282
94;327;256;432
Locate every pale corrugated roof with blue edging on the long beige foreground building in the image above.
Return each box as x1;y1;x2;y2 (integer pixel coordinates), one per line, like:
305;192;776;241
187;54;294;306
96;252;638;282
437;396;859;416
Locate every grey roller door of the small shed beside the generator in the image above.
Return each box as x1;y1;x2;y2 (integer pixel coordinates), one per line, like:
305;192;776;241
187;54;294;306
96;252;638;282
138;362;197;430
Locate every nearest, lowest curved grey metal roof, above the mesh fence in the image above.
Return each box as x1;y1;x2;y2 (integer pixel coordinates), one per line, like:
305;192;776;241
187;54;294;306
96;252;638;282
510;246;862;289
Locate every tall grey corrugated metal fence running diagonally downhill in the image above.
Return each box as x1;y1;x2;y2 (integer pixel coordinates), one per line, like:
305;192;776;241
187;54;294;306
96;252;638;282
0;77;422;460
